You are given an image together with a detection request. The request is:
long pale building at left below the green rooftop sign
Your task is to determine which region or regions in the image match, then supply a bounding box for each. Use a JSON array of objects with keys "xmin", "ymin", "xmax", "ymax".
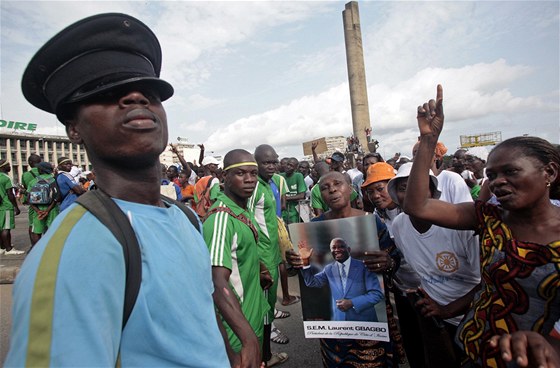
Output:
[{"xmin": 0, "ymin": 132, "xmax": 91, "ymax": 183}]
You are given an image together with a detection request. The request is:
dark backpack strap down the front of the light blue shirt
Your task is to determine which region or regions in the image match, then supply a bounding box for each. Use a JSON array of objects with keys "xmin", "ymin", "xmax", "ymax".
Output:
[{"xmin": 76, "ymin": 190, "xmax": 142, "ymax": 329}]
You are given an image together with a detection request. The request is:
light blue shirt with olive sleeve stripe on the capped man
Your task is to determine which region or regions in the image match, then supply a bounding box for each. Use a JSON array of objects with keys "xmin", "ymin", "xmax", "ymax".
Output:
[{"xmin": 4, "ymin": 200, "xmax": 229, "ymax": 367}]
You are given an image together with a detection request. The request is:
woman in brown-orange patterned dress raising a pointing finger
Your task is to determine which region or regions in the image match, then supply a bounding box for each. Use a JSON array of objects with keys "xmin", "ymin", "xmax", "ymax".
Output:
[{"xmin": 404, "ymin": 85, "xmax": 560, "ymax": 367}]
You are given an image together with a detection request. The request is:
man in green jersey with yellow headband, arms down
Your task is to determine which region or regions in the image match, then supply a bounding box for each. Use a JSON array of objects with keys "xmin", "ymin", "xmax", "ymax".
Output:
[{"xmin": 203, "ymin": 149, "xmax": 269, "ymax": 367}]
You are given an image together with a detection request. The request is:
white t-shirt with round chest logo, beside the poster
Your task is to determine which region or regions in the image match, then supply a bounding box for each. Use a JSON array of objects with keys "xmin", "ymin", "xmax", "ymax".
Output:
[{"xmin": 392, "ymin": 213, "xmax": 480, "ymax": 325}]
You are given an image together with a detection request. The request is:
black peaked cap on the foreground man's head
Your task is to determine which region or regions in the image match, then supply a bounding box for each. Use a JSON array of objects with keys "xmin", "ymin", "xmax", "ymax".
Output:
[{"xmin": 21, "ymin": 13, "xmax": 173, "ymax": 117}]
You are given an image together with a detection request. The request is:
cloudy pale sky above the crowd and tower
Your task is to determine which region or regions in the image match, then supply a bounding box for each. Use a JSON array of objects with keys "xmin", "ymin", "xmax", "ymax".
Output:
[{"xmin": 0, "ymin": 0, "xmax": 560, "ymax": 158}]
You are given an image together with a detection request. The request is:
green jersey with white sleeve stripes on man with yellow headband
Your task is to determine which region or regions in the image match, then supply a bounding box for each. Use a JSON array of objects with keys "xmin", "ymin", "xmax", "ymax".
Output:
[{"xmin": 203, "ymin": 193, "xmax": 269, "ymax": 352}]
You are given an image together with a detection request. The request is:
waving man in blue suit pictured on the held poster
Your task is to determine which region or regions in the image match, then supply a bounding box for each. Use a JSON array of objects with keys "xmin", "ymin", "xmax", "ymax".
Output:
[{"xmin": 300, "ymin": 238, "xmax": 384, "ymax": 322}]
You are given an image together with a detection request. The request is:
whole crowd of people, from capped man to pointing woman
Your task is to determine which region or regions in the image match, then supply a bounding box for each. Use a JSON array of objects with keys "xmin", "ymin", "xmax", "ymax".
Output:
[{"xmin": 4, "ymin": 13, "xmax": 560, "ymax": 368}]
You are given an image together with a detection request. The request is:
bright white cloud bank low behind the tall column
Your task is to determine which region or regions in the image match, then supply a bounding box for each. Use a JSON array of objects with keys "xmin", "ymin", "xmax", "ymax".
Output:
[{"xmin": 207, "ymin": 60, "xmax": 545, "ymax": 155}]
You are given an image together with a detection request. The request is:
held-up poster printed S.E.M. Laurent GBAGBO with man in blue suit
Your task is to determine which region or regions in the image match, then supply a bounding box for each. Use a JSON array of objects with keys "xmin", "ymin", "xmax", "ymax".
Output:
[{"xmin": 289, "ymin": 216, "xmax": 389, "ymax": 341}]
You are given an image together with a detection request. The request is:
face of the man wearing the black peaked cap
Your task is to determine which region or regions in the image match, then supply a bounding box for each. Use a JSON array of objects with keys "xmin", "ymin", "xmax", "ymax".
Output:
[{"xmin": 66, "ymin": 85, "xmax": 168, "ymax": 168}]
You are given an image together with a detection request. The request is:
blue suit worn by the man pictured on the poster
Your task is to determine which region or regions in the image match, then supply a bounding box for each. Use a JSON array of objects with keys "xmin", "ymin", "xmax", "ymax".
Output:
[{"xmin": 301, "ymin": 258, "xmax": 384, "ymax": 322}]
